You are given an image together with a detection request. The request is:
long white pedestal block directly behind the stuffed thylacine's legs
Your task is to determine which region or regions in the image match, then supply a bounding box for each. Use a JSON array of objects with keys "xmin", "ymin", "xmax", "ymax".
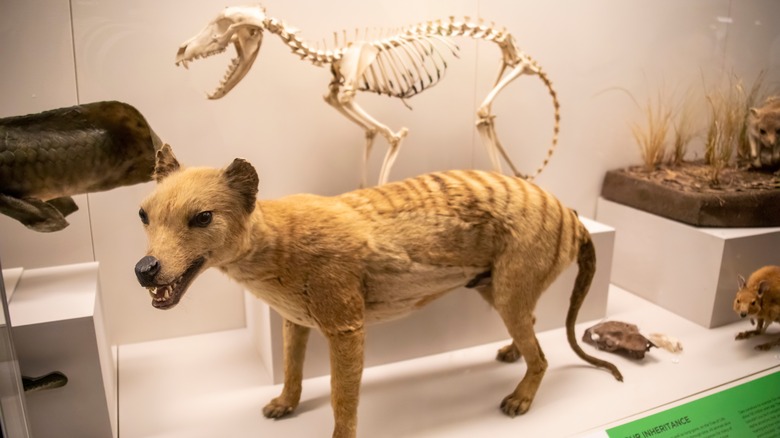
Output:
[{"xmin": 246, "ymin": 218, "xmax": 615, "ymax": 383}]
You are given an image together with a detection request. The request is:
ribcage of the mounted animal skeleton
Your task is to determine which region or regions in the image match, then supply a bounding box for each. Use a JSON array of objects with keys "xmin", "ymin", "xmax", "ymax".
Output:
[{"xmin": 359, "ymin": 34, "xmax": 458, "ymax": 99}]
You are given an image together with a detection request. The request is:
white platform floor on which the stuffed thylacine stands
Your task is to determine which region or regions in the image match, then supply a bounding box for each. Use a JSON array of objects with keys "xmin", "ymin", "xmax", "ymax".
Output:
[{"xmin": 119, "ymin": 286, "xmax": 780, "ymax": 438}]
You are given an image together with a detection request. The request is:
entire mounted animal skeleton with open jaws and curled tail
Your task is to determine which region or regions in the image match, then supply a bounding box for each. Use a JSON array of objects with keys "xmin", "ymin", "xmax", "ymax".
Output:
[{"xmin": 176, "ymin": 6, "xmax": 560, "ymax": 185}]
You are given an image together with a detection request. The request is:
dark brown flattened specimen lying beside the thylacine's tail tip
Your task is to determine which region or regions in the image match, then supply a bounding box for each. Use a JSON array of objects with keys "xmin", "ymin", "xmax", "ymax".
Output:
[{"xmin": 582, "ymin": 321, "xmax": 655, "ymax": 359}]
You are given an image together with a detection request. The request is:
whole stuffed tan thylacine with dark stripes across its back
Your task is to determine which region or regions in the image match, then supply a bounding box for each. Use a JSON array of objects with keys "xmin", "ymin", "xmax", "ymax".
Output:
[{"xmin": 137, "ymin": 149, "xmax": 621, "ymax": 436}]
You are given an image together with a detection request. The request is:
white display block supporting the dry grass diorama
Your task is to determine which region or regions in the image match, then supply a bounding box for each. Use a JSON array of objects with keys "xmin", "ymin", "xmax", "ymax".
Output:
[{"xmin": 596, "ymin": 198, "xmax": 780, "ymax": 327}]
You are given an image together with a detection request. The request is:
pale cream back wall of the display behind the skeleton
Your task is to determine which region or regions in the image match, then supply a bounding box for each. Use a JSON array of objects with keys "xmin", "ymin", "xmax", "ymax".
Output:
[{"xmin": 0, "ymin": 0, "xmax": 780, "ymax": 344}]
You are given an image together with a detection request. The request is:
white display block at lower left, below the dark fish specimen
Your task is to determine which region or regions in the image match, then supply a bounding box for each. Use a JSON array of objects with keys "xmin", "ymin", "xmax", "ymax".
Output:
[{"xmin": 8, "ymin": 263, "xmax": 118, "ymax": 438}]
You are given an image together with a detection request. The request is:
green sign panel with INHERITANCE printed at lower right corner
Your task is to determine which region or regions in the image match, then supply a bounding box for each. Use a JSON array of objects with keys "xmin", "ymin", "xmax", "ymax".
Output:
[{"xmin": 607, "ymin": 372, "xmax": 780, "ymax": 438}]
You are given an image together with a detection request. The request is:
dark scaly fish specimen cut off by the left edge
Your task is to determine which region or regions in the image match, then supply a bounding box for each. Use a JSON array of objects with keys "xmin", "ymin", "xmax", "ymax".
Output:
[{"xmin": 0, "ymin": 101, "xmax": 162, "ymax": 232}]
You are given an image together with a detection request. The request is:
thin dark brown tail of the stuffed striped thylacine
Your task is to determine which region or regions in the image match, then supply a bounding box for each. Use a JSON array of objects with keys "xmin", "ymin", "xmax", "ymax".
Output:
[{"xmin": 566, "ymin": 225, "xmax": 623, "ymax": 382}]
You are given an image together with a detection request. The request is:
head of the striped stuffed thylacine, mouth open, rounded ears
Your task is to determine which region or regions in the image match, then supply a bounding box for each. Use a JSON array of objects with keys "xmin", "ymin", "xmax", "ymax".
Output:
[{"xmin": 135, "ymin": 145, "xmax": 258, "ymax": 309}]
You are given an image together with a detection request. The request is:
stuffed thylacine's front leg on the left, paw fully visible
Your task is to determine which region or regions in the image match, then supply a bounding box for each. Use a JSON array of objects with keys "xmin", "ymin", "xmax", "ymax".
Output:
[{"xmin": 263, "ymin": 319, "xmax": 311, "ymax": 418}]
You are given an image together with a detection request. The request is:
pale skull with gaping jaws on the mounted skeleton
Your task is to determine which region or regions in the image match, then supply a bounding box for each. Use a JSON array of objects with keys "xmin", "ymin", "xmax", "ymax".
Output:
[{"xmin": 176, "ymin": 6, "xmax": 266, "ymax": 99}]
